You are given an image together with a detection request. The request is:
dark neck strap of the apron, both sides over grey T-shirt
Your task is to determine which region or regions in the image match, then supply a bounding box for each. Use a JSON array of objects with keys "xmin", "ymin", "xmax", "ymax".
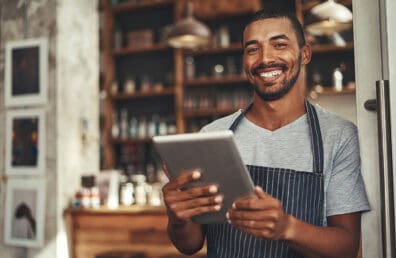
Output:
[{"xmin": 229, "ymin": 100, "xmax": 324, "ymax": 174}]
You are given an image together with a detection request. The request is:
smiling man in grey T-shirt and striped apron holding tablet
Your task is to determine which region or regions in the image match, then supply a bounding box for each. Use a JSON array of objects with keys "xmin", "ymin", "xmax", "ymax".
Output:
[{"xmin": 163, "ymin": 11, "xmax": 369, "ymax": 258}]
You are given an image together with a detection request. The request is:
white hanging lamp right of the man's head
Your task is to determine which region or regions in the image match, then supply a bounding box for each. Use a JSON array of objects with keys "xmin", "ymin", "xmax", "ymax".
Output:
[{"xmin": 306, "ymin": 0, "xmax": 352, "ymax": 36}]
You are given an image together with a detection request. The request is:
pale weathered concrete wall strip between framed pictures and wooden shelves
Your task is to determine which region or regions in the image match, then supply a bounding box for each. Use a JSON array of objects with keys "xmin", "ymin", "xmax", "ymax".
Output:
[{"xmin": 56, "ymin": 0, "xmax": 99, "ymax": 258}]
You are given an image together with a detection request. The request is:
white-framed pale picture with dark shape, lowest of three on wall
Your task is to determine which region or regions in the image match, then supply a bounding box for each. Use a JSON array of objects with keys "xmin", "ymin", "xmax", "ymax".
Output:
[{"xmin": 4, "ymin": 178, "xmax": 45, "ymax": 247}]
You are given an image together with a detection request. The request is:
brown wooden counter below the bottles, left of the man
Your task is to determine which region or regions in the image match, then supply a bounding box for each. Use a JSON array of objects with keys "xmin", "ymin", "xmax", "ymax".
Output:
[{"xmin": 65, "ymin": 206, "xmax": 206, "ymax": 258}]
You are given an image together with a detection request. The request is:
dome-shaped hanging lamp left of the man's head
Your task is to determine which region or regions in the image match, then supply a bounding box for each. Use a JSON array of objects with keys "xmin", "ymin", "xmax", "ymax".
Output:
[{"xmin": 167, "ymin": 1, "xmax": 211, "ymax": 49}]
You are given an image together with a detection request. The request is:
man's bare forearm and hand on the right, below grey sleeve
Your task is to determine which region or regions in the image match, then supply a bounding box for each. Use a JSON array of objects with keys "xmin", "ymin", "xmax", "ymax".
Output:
[{"xmin": 228, "ymin": 188, "xmax": 360, "ymax": 258}]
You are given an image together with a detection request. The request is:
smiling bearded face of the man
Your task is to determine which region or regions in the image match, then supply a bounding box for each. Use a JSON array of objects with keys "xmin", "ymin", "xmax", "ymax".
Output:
[{"xmin": 243, "ymin": 18, "xmax": 309, "ymax": 101}]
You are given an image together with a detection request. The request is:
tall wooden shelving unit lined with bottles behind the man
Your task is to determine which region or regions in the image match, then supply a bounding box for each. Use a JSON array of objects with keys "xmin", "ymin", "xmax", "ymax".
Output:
[{"xmin": 101, "ymin": 0, "xmax": 354, "ymax": 173}]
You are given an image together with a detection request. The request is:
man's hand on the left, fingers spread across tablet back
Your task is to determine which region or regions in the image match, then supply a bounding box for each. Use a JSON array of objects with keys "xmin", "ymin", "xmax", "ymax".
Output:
[{"xmin": 162, "ymin": 168, "xmax": 223, "ymax": 224}]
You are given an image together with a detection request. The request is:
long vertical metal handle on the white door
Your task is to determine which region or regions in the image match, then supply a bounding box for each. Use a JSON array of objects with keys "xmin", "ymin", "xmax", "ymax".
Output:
[{"xmin": 376, "ymin": 80, "xmax": 396, "ymax": 258}]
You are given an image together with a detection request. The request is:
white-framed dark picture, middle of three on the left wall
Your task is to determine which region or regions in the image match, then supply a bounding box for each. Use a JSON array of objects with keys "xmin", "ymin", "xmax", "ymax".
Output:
[{"xmin": 5, "ymin": 109, "xmax": 46, "ymax": 175}]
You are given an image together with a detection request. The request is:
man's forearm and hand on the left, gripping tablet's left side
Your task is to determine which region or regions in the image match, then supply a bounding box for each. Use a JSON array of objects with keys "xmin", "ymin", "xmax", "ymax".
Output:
[{"xmin": 163, "ymin": 171, "xmax": 223, "ymax": 255}]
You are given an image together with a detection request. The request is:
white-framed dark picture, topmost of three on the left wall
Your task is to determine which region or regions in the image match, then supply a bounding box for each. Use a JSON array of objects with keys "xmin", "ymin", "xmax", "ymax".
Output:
[{"xmin": 4, "ymin": 38, "xmax": 48, "ymax": 107}]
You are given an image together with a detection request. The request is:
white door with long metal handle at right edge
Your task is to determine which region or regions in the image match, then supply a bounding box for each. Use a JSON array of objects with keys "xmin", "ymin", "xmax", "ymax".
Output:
[{"xmin": 353, "ymin": 0, "xmax": 396, "ymax": 258}]
